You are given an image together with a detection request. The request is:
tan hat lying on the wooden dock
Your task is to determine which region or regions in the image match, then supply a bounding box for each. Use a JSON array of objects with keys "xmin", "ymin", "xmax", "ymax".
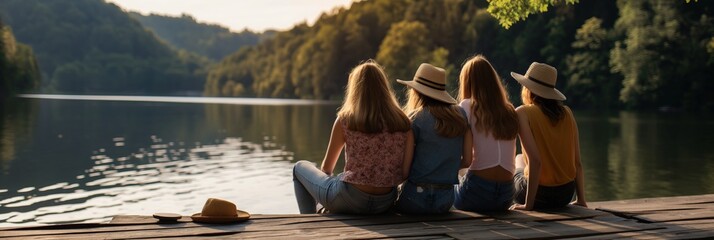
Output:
[{"xmin": 191, "ymin": 198, "xmax": 250, "ymax": 223}]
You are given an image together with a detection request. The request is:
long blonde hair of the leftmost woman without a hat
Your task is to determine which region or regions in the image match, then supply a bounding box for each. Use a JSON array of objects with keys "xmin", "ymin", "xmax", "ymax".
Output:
[{"xmin": 337, "ymin": 60, "xmax": 411, "ymax": 133}]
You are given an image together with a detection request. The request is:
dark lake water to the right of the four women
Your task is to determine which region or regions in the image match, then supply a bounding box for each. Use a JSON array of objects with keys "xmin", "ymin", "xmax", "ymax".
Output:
[{"xmin": 578, "ymin": 112, "xmax": 714, "ymax": 200}]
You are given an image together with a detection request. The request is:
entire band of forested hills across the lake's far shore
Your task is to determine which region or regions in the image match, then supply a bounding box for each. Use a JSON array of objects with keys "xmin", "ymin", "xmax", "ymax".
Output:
[{"xmin": 0, "ymin": 0, "xmax": 714, "ymax": 112}]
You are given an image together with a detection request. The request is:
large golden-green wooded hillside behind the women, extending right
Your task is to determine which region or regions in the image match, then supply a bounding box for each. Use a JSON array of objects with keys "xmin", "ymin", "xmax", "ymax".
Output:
[{"xmin": 204, "ymin": 0, "xmax": 714, "ymax": 111}]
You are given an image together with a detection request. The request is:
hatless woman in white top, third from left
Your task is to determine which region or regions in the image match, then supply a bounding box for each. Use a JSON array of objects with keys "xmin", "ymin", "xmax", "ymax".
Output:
[{"xmin": 454, "ymin": 55, "xmax": 518, "ymax": 211}]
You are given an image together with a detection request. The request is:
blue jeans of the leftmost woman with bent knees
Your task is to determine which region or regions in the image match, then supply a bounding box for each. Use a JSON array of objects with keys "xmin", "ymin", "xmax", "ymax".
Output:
[{"xmin": 293, "ymin": 160, "xmax": 397, "ymax": 214}]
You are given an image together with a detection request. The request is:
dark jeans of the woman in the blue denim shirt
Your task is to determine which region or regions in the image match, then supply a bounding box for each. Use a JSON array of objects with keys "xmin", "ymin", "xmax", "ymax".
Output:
[{"xmin": 395, "ymin": 181, "xmax": 454, "ymax": 214}]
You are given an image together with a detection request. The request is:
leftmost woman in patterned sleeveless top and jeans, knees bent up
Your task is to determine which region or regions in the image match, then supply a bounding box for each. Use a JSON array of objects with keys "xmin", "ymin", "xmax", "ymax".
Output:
[{"xmin": 293, "ymin": 60, "xmax": 414, "ymax": 214}]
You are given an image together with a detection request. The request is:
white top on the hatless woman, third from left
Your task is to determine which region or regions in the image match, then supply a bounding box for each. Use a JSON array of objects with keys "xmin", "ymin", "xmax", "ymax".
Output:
[{"xmin": 459, "ymin": 99, "xmax": 516, "ymax": 173}]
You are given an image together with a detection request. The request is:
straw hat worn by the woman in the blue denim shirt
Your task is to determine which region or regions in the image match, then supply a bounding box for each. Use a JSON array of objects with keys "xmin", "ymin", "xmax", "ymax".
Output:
[{"xmin": 397, "ymin": 63, "xmax": 456, "ymax": 104}]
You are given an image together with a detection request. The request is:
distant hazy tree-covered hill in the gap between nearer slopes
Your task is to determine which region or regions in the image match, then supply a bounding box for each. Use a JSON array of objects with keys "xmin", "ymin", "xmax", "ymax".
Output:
[{"xmin": 130, "ymin": 12, "xmax": 262, "ymax": 61}]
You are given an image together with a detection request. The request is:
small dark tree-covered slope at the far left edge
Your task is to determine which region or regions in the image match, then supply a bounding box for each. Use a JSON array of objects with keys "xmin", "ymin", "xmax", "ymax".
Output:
[{"xmin": 0, "ymin": 21, "xmax": 40, "ymax": 99}]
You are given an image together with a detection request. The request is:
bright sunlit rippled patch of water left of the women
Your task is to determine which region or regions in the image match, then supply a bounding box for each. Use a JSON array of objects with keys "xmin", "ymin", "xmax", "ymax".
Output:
[{"xmin": 0, "ymin": 136, "xmax": 297, "ymax": 226}]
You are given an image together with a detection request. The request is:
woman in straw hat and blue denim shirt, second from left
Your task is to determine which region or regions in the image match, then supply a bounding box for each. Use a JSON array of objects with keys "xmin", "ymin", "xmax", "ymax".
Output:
[{"xmin": 395, "ymin": 63, "xmax": 471, "ymax": 214}]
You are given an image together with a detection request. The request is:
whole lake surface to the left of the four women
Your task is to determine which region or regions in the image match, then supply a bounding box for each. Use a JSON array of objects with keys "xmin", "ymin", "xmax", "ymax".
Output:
[{"xmin": 0, "ymin": 96, "xmax": 337, "ymax": 226}]
